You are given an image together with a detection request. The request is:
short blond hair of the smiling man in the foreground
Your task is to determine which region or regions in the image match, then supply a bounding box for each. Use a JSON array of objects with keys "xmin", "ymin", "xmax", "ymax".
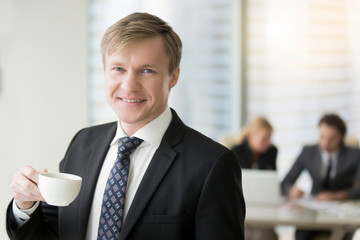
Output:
[{"xmin": 101, "ymin": 13, "xmax": 182, "ymax": 74}]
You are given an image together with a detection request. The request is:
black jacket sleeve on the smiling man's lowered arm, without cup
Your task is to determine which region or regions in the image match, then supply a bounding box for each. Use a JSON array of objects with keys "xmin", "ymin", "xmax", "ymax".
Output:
[{"xmin": 195, "ymin": 151, "xmax": 245, "ymax": 240}]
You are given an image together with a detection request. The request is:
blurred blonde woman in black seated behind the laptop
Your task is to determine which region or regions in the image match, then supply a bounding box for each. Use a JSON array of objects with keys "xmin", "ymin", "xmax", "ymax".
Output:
[{"xmin": 232, "ymin": 117, "xmax": 278, "ymax": 240}]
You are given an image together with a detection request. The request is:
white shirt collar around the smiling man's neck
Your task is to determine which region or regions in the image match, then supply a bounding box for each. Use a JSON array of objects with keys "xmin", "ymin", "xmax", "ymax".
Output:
[{"xmin": 110, "ymin": 107, "xmax": 172, "ymax": 148}]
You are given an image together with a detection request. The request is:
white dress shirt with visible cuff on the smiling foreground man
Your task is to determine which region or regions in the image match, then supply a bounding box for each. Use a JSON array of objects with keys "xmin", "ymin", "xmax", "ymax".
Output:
[{"xmin": 13, "ymin": 107, "xmax": 172, "ymax": 240}]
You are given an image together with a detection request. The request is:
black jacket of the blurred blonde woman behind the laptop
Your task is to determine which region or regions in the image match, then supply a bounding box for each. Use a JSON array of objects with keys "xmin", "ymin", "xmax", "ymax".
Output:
[{"xmin": 232, "ymin": 140, "xmax": 277, "ymax": 170}]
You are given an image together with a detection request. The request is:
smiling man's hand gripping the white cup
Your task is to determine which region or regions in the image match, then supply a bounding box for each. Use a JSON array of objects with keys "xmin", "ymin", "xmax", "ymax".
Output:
[{"xmin": 10, "ymin": 167, "xmax": 47, "ymax": 209}]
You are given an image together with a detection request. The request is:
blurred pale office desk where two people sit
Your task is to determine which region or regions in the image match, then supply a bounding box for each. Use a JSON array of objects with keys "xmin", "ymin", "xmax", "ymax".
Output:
[{"xmin": 245, "ymin": 202, "xmax": 360, "ymax": 240}]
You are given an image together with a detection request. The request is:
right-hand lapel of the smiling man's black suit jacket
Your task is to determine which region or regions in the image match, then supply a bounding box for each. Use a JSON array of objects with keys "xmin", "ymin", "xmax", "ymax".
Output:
[{"xmin": 120, "ymin": 110, "xmax": 185, "ymax": 240}]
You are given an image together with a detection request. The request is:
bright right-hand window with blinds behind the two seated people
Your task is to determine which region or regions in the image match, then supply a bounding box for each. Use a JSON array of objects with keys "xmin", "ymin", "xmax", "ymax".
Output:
[{"xmin": 246, "ymin": 0, "xmax": 360, "ymax": 181}]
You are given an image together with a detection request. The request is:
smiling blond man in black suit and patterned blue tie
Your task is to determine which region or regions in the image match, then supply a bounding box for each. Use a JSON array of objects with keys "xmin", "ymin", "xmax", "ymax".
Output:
[{"xmin": 7, "ymin": 13, "xmax": 245, "ymax": 240}]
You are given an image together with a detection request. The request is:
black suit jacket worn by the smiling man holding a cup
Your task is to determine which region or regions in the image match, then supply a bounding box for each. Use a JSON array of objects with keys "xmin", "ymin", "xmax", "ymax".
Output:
[{"xmin": 7, "ymin": 111, "xmax": 245, "ymax": 240}]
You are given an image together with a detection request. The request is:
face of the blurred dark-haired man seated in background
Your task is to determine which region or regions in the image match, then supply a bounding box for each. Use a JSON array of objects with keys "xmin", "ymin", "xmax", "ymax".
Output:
[{"xmin": 319, "ymin": 123, "xmax": 343, "ymax": 153}]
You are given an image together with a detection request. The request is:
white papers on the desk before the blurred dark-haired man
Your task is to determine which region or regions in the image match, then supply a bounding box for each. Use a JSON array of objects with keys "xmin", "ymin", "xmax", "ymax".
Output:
[{"xmin": 293, "ymin": 198, "xmax": 360, "ymax": 218}]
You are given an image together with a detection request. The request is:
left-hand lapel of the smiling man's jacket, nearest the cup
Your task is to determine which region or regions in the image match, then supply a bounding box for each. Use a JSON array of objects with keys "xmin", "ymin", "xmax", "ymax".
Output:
[{"xmin": 79, "ymin": 123, "xmax": 117, "ymax": 239}]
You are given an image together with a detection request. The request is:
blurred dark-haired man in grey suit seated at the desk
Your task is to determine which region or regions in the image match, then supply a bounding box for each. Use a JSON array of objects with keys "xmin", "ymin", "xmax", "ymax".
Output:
[{"xmin": 281, "ymin": 114, "xmax": 360, "ymax": 240}]
